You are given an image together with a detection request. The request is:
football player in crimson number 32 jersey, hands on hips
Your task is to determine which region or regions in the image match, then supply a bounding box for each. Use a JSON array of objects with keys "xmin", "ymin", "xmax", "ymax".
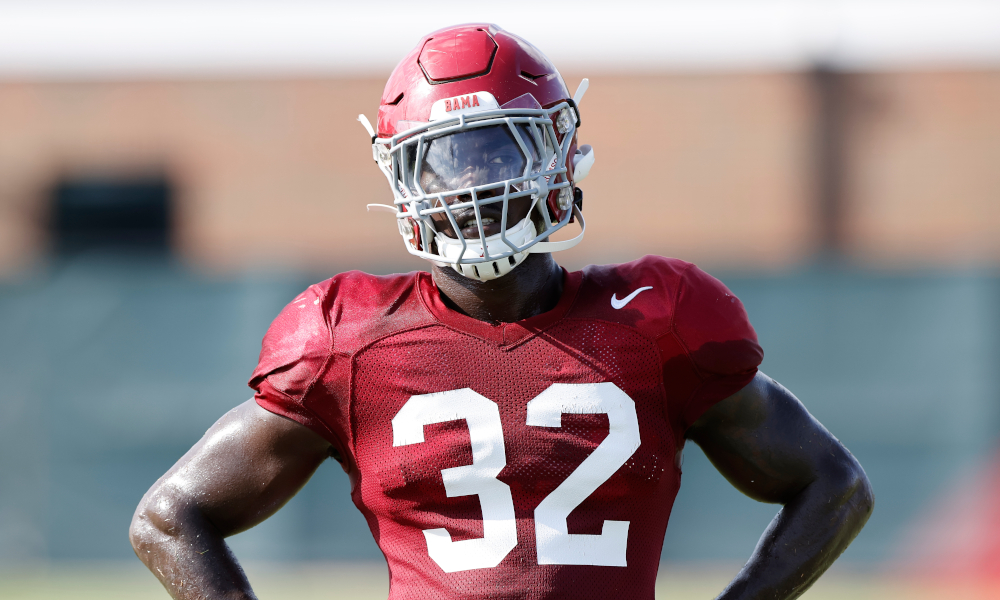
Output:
[{"xmin": 131, "ymin": 24, "xmax": 873, "ymax": 600}]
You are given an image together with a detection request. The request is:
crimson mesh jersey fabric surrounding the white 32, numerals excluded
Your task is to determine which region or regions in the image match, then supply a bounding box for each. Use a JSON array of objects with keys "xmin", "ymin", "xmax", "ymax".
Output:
[{"xmin": 251, "ymin": 257, "xmax": 761, "ymax": 600}]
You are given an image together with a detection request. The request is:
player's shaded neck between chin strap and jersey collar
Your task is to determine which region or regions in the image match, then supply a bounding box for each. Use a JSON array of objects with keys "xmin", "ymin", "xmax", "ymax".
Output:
[{"xmin": 431, "ymin": 254, "xmax": 563, "ymax": 323}]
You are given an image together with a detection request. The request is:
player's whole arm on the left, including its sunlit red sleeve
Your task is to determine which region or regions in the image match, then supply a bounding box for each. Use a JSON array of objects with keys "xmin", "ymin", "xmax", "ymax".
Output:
[{"xmin": 129, "ymin": 284, "xmax": 346, "ymax": 600}]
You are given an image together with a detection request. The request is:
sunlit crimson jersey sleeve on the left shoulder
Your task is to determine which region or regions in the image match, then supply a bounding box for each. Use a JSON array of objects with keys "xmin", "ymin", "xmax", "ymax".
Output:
[{"xmin": 249, "ymin": 285, "xmax": 343, "ymax": 448}]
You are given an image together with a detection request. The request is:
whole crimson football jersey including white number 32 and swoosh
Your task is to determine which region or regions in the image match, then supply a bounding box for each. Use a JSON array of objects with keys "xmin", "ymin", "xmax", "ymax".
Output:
[{"xmin": 250, "ymin": 256, "xmax": 763, "ymax": 600}]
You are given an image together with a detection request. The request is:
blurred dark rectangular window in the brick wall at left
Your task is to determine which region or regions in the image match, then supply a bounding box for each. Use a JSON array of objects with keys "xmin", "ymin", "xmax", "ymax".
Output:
[{"xmin": 51, "ymin": 177, "xmax": 173, "ymax": 254}]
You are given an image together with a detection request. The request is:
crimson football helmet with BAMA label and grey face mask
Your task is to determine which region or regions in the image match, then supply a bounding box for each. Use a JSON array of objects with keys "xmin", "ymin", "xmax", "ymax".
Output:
[{"xmin": 358, "ymin": 24, "xmax": 594, "ymax": 281}]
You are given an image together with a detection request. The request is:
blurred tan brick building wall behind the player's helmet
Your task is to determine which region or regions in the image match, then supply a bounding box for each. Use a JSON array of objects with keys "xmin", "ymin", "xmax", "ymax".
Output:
[{"xmin": 0, "ymin": 71, "xmax": 1000, "ymax": 276}]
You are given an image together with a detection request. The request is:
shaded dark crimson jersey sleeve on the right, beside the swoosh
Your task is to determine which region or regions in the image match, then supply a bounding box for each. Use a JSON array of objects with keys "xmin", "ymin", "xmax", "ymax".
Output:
[{"xmin": 673, "ymin": 265, "xmax": 764, "ymax": 431}]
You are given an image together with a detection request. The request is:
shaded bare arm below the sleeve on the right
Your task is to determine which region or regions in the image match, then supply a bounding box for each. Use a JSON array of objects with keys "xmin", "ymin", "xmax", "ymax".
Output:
[{"xmin": 687, "ymin": 373, "xmax": 875, "ymax": 600}]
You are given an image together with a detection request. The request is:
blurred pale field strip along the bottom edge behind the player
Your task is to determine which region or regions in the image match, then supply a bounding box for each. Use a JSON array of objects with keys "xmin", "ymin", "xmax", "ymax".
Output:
[{"xmin": 0, "ymin": 562, "xmax": 1000, "ymax": 600}]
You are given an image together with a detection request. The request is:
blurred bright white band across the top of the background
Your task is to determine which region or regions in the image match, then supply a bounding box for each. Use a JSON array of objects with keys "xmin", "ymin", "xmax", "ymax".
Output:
[{"xmin": 0, "ymin": 0, "xmax": 1000, "ymax": 78}]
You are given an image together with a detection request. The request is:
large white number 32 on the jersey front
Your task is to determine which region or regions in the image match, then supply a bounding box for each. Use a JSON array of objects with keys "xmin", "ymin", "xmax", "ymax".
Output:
[{"xmin": 392, "ymin": 382, "xmax": 640, "ymax": 573}]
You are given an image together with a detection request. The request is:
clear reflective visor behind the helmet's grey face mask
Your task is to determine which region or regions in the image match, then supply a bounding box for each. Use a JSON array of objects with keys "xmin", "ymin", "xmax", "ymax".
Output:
[{"xmin": 410, "ymin": 124, "xmax": 542, "ymax": 203}]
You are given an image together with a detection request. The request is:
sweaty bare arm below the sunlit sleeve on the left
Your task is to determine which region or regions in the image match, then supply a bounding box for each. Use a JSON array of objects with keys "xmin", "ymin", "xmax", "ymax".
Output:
[{"xmin": 129, "ymin": 400, "xmax": 331, "ymax": 600}]
